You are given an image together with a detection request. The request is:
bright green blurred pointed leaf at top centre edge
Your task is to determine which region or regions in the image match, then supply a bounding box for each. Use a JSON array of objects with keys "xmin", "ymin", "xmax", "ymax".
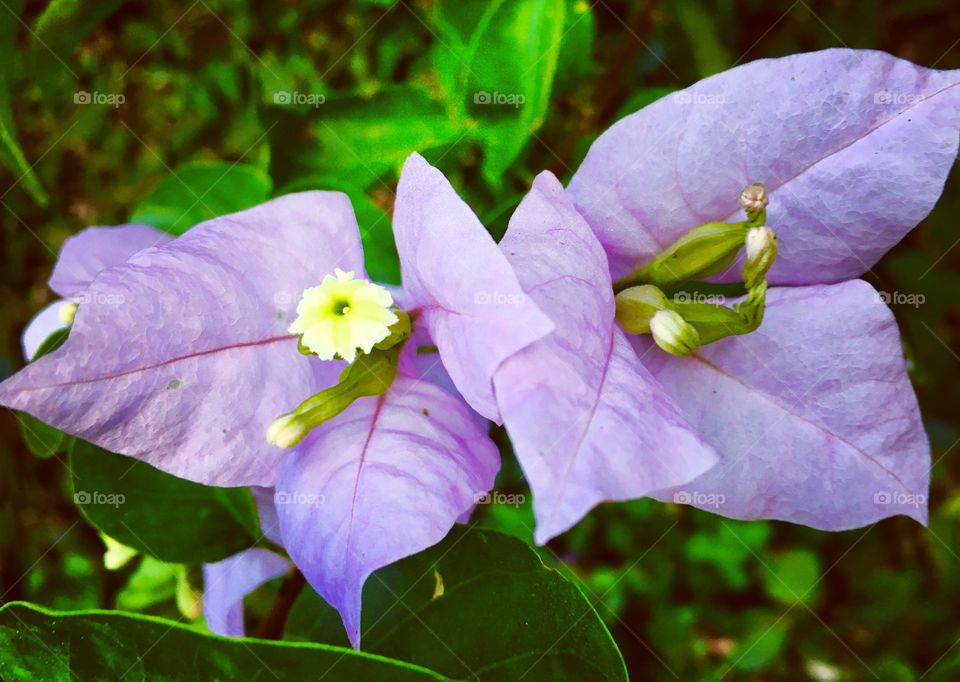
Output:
[{"xmin": 445, "ymin": 0, "xmax": 567, "ymax": 187}]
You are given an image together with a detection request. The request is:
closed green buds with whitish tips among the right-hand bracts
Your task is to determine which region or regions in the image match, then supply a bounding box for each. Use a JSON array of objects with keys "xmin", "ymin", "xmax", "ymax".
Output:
[{"xmin": 615, "ymin": 183, "xmax": 777, "ymax": 356}]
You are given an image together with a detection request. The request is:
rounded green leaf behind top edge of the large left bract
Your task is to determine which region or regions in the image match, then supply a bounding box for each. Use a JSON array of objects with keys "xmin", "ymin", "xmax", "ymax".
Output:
[{"xmin": 130, "ymin": 161, "xmax": 273, "ymax": 235}]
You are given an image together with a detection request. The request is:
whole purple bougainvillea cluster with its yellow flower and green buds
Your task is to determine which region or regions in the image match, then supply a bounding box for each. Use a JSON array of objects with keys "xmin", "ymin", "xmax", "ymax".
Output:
[{"xmin": 0, "ymin": 50, "xmax": 960, "ymax": 646}]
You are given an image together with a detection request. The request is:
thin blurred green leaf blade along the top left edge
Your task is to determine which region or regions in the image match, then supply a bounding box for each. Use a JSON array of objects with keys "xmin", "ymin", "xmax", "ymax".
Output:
[{"xmin": 0, "ymin": 0, "xmax": 48, "ymax": 206}]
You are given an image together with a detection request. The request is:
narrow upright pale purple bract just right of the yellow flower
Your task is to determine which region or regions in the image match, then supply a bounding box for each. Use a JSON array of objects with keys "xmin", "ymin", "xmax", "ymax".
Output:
[{"xmin": 393, "ymin": 154, "xmax": 552, "ymax": 422}]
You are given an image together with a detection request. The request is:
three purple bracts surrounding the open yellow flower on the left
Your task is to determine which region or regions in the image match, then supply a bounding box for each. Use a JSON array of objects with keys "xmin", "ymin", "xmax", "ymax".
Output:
[{"xmin": 0, "ymin": 155, "xmax": 552, "ymax": 645}]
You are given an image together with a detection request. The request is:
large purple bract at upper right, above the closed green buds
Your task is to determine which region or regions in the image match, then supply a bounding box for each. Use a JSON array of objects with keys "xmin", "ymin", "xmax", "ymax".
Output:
[{"xmin": 569, "ymin": 49, "xmax": 960, "ymax": 284}]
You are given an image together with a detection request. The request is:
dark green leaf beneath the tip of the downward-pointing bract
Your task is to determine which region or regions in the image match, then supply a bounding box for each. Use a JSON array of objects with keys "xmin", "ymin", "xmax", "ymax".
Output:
[{"xmin": 286, "ymin": 526, "xmax": 626, "ymax": 682}]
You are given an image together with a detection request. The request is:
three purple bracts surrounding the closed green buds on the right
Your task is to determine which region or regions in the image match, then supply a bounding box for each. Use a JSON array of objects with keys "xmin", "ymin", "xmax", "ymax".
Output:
[{"xmin": 495, "ymin": 50, "xmax": 960, "ymax": 542}]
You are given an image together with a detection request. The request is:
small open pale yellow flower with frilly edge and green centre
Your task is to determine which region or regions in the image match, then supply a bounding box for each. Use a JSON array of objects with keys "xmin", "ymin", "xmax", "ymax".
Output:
[{"xmin": 290, "ymin": 269, "xmax": 398, "ymax": 362}]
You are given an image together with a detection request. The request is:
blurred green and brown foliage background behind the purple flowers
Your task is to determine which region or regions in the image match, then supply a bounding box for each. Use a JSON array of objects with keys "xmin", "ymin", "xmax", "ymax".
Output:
[{"xmin": 0, "ymin": 0, "xmax": 960, "ymax": 681}]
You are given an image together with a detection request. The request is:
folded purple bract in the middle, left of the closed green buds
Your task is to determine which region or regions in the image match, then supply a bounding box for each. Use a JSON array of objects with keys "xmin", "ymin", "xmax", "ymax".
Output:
[{"xmin": 494, "ymin": 172, "xmax": 716, "ymax": 543}]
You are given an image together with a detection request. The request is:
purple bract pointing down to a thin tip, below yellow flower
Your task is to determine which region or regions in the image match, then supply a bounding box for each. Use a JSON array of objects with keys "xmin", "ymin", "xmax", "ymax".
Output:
[{"xmin": 276, "ymin": 376, "xmax": 500, "ymax": 647}]
